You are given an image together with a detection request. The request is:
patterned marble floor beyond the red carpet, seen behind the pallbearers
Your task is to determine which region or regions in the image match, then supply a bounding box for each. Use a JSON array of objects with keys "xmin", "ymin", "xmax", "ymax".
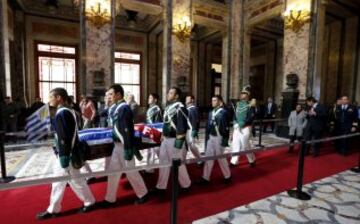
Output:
[{"xmin": 2, "ymin": 130, "xmax": 287, "ymax": 181}]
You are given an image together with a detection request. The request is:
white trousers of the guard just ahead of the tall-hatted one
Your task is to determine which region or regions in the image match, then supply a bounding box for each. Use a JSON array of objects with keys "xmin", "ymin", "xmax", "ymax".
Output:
[{"xmin": 203, "ymin": 135, "xmax": 231, "ymax": 180}]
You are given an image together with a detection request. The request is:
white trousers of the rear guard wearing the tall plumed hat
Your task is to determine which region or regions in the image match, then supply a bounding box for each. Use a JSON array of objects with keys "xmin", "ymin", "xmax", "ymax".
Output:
[{"xmin": 231, "ymin": 126, "xmax": 255, "ymax": 165}]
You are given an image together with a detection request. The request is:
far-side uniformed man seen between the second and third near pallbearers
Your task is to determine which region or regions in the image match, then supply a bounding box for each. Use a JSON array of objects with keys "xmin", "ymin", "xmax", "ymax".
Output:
[{"xmin": 146, "ymin": 93, "xmax": 162, "ymax": 173}]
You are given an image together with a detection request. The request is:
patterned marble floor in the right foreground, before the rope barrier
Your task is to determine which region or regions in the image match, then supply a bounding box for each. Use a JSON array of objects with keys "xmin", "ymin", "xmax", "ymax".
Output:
[{"xmin": 193, "ymin": 171, "xmax": 360, "ymax": 224}]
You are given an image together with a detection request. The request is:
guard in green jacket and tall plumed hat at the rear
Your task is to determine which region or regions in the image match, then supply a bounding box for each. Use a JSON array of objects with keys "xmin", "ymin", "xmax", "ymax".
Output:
[{"xmin": 231, "ymin": 90, "xmax": 255, "ymax": 167}]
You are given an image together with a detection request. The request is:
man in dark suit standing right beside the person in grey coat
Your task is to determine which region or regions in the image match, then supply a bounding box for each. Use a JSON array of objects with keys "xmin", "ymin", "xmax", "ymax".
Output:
[{"xmin": 304, "ymin": 97, "xmax": 327, "ymax": 157}]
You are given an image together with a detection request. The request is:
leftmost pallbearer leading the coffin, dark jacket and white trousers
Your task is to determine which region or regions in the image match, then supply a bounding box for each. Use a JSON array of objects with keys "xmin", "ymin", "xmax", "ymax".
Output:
[{"xmin": 37, "ymin": 88, "xmax": 95, "ymax": 220}]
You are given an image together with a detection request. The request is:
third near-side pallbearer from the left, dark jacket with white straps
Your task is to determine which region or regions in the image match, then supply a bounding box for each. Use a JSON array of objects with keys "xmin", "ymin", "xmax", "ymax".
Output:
[{"xmin": 155, "ymin": 87, "xmax": 191, "ymax": 192}]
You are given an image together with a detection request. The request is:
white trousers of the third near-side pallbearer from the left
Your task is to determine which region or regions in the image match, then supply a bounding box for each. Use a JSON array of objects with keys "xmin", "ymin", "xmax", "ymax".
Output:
[{"xmin": 156, "ymin": 137, "xmax": 191, "ymax": 189}]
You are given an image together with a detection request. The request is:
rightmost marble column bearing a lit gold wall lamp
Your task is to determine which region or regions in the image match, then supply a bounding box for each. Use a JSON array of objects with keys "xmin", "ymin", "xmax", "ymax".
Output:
[{"xmin": 283, "ymin": 0, "xmax": 325, "ymax": 100}]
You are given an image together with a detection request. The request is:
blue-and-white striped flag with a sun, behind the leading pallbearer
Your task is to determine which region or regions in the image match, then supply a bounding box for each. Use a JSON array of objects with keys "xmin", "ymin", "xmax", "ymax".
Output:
[{"xmin": 25, "ymin": 104, "xmax": 51, "ymax": 142}]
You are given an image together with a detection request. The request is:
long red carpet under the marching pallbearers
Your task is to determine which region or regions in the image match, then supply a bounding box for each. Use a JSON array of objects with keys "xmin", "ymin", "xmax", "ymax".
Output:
[{"xmin": 0, "ymin": 144, "xmax": 358, "ymax": 224}]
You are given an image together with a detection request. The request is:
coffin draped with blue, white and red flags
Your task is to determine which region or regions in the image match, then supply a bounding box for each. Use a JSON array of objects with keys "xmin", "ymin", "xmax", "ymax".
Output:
[{"xmin": 79, "ymin": 123, "xmax": 163, "ymax": 160}]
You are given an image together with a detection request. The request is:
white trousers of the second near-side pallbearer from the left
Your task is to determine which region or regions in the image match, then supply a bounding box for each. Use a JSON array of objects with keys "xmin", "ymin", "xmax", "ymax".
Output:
[{"xmin": 105, "ymin": 142, "xmax": 148, "ymax": 202}]
